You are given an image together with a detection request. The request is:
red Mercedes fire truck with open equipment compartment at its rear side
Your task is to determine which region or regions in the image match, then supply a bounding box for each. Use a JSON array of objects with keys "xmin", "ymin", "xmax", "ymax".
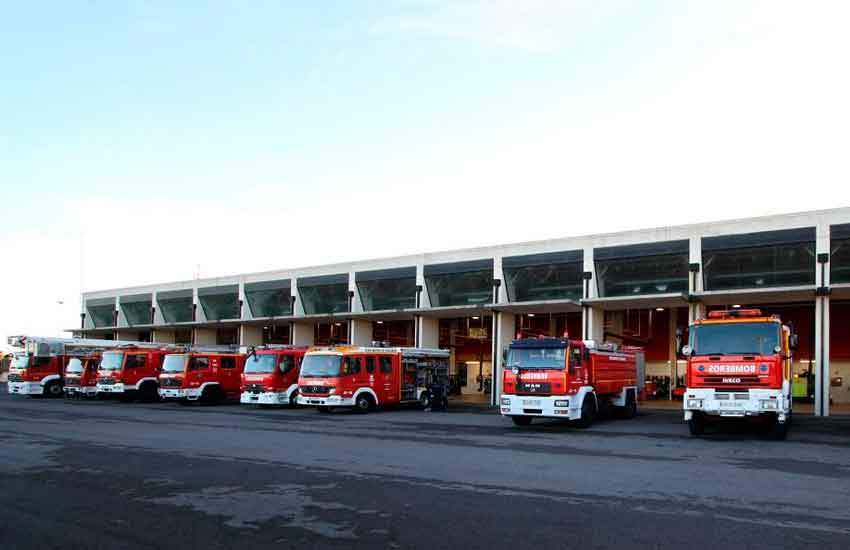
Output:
[{"xmin": 298, "ymin": 346, "xmax": 449, "ymax": 412}]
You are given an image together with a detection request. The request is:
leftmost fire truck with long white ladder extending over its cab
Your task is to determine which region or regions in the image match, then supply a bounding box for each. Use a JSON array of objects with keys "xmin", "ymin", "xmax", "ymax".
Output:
[{"xmin": 8, "ymin": 336, "xmax": 143, "ymax": 397}]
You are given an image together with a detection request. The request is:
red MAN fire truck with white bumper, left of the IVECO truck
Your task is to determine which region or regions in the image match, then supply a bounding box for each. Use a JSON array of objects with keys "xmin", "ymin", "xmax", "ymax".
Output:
[{"xmin": 500, "ymin": 336, "xmax": 646, "ymax": 428}]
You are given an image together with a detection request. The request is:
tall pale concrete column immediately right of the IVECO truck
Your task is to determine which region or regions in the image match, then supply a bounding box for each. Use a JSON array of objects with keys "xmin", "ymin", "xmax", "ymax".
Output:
[{"xmin": 815, "ymin": 223, "xmax": 830, "ymax": 416}]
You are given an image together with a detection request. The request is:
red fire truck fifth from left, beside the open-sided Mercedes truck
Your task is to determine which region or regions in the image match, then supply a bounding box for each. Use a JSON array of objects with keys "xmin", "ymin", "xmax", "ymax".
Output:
[{"xmin": 239, "ymin": 344, "xmax": 309, "ymax": 406}]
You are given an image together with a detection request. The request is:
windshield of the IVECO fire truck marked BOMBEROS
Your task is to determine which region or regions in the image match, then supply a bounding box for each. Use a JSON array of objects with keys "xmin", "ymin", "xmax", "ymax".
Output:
[{"xmin": 691, "ymin": 323, "xmax": 780, "ymax": 355}]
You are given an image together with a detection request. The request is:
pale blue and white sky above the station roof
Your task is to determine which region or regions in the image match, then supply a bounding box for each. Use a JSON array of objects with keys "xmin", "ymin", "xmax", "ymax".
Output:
[{"xmin": 0, "ymin": 0, "xmax": 850, "ymax": 335}]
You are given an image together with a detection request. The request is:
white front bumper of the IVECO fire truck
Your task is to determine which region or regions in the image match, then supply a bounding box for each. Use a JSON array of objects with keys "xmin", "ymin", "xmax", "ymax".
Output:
[{"xmin": 683, "ymin": 388, "xmax": 791, "ymax": 422}]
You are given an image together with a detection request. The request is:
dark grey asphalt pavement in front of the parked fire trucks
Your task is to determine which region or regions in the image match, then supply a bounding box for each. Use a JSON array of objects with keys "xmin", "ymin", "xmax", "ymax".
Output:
[{"xmin": 0, "ymin": 385, "xmax": 850, "ymax": 550}]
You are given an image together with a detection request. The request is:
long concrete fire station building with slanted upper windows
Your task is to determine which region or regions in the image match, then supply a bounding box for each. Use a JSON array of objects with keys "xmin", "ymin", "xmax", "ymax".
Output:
[{"xmin": 74, "ymin": 208, "xmax": 850, "ymax": 415}]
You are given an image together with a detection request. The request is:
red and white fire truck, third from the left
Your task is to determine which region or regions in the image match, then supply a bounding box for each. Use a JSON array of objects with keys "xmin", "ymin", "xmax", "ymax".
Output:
[{"xmin": 97, "ymin": 343, "xmax": 176, "ymax": 402}]
